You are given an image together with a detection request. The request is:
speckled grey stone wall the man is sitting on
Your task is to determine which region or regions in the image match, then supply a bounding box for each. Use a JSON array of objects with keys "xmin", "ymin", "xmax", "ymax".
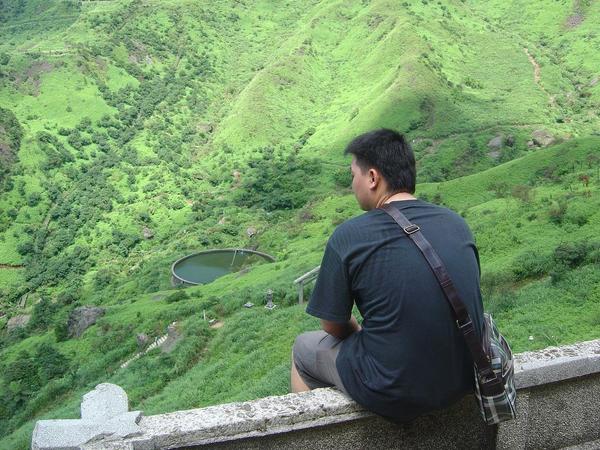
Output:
[{"xmin": 32, "ymin": 340, "xmax": 600, "ymax": 450}]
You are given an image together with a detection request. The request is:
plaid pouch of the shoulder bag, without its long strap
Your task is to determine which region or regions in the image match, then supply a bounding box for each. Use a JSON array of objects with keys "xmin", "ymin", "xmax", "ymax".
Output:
[{"xmin": 474, "ymin": 313, "xmax": 517, "ymax": 425}]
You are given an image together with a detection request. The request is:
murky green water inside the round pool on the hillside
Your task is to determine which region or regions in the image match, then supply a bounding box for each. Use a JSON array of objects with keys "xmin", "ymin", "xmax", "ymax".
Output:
[{"xmin": 173, "ymin": 250, "xmax": 267, "ymax": 284}]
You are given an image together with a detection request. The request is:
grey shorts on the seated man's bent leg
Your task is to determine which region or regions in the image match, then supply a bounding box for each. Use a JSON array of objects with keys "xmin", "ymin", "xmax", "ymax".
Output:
[{"xmin": 292, "ymin": 331, "xmax": 347, "ymax": 394}]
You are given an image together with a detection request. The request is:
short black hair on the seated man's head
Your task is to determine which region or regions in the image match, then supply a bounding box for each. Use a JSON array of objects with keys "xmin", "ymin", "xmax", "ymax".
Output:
[{"xmin": 344, "ymin": 128, "xmax": 417, "ymax": 194}]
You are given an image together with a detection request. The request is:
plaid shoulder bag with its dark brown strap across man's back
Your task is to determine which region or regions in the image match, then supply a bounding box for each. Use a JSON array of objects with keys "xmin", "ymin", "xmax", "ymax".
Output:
[{"xmin": 381, "ymin": 204, "xmax": 517, "ymax": 425}]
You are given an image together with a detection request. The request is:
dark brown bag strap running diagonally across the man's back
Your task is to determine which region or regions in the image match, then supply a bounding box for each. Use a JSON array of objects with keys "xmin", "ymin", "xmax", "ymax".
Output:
[{"xmin": 380, "ymin": 203, "xmax": 502, "ymax": 387}]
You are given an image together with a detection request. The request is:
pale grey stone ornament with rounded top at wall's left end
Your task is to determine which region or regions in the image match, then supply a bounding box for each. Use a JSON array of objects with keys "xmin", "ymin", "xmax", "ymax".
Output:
[{"xmin": 31, "ymin": 383, "xmax": 142, "ymax": 450}]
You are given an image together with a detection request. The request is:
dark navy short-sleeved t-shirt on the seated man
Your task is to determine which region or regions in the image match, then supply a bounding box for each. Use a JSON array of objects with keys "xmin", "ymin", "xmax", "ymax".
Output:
[{"xmin": 306, "ymin": 200, "xmax": 483, "ymax": 421}]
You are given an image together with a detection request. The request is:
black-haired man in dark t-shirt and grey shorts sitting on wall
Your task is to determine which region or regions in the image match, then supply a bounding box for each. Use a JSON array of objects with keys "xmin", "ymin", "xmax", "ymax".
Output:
[{"xmin": 291, "ymin": 129, "xmax": 483, "ymax": 421}]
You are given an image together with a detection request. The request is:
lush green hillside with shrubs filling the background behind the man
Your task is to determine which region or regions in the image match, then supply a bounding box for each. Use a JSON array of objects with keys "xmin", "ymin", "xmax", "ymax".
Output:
[{"xmin": 0, "ymin": 0, "xmax": 600, "ymax": 448}]
